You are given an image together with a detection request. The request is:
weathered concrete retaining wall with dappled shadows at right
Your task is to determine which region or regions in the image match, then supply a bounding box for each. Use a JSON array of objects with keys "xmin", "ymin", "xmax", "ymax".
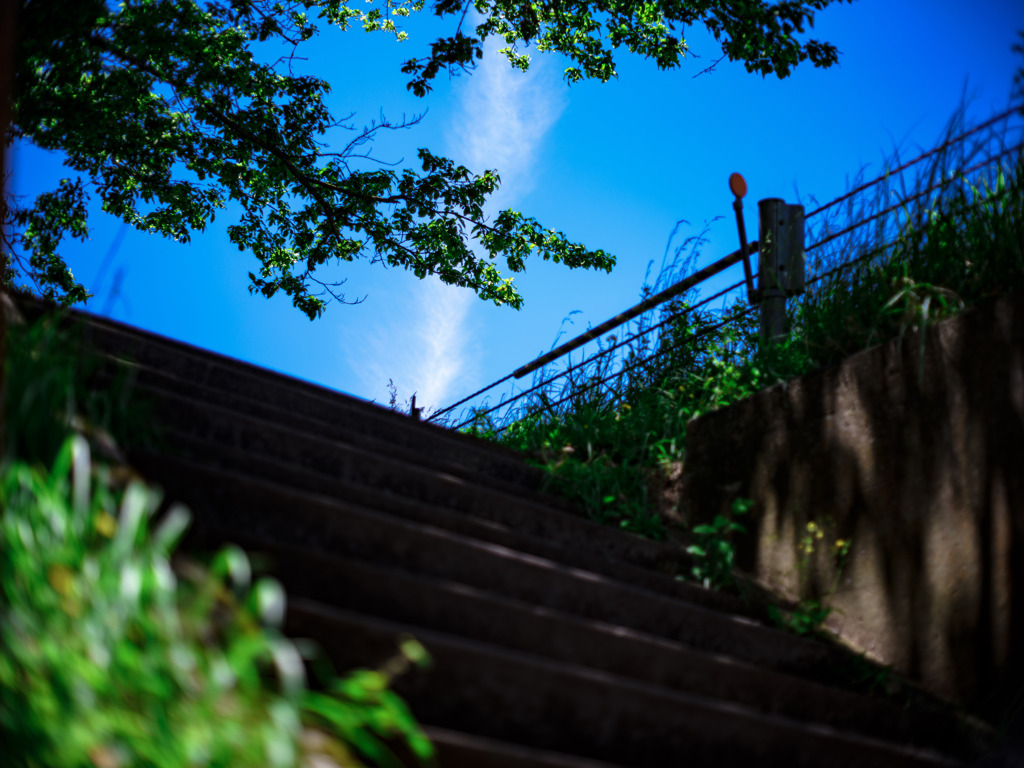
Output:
[{"xmin": 681, "ymin": 295, "xmax": 1024, "ymax": 711}]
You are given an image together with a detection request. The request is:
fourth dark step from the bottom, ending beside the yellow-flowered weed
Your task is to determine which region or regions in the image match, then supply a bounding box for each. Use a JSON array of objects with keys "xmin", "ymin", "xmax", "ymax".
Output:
[{"xmin": 161, "ymin": 462, "xmax": 837, "ymax": 678}]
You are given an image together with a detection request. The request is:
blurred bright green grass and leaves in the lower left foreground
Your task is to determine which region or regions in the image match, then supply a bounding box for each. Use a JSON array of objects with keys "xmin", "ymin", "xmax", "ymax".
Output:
[{"xmin": 0, "ymin": 318, "xmax": 433, "ymax": 768}]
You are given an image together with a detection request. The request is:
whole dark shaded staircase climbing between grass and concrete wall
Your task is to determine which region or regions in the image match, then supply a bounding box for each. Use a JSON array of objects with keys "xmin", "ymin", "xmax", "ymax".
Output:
[{"xmin": 41, "ymin": 303, "xmax": 999, "ymax": 768}]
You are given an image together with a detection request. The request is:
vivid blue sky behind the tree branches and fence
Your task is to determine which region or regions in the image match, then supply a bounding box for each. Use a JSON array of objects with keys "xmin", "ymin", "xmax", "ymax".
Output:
[{"xmin": 13, "ymin": 0, "xmax": 1024, "ymax": 417}]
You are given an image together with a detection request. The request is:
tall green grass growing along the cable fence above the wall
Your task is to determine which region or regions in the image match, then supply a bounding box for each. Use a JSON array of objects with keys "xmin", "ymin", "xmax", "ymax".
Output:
[{"xmin": 467, "ymin": 96, "xmax": 1024, "ymax": 539}]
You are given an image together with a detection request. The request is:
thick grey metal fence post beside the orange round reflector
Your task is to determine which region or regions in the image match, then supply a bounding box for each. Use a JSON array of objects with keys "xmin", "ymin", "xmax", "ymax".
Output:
[{"xmin": 758, "ymin": 198, "xmax": 804, "ymax": 343}]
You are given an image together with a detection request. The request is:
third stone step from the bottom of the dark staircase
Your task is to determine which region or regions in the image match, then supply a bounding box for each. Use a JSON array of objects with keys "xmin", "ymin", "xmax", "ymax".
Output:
[{"xmin": 201, "ymin": 531, "xmax": 970, "ymax": 756}]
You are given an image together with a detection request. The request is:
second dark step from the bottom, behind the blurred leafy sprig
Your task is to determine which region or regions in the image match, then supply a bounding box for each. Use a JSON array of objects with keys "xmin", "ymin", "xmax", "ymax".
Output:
[{"xmin": 286, "ymin": 598, "xmax": 962, "ymax": 768}]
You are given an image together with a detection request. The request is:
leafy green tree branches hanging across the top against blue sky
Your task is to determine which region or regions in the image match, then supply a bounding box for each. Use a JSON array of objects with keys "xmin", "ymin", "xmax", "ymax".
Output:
[{"xmin": 3, "ymin": 0, "xmax": 843, "ymax": 318}]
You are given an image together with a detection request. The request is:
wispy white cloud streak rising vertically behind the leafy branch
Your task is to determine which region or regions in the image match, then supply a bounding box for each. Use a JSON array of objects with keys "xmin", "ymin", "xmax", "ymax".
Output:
[{"xmin": 348, "ymin": 37, "xmax": 564, "ymax": 408}]
